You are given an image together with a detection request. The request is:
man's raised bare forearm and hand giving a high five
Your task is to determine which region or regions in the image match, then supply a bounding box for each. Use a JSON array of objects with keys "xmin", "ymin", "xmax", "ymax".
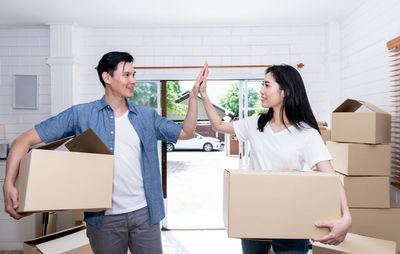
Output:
[{"xmin": 178, "ymin": 62, "xmax": 208, "ymax": 139}]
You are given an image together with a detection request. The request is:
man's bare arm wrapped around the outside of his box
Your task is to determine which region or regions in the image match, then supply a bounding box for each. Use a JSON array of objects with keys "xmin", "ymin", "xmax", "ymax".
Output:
[{"xmin": 3, "ymin": 128, "xmax": 42, "ymax": 219}]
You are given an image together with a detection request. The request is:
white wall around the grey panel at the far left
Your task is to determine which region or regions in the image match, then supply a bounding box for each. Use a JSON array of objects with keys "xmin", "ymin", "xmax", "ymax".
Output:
[{"xmin": 0, "ymin": 27, "xmax": 50, "ymax": 250}]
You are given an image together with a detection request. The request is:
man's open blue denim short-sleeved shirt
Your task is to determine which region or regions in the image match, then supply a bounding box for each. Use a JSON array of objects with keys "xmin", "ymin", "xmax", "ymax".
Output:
[{"xmin": 35, "ymin": 97, "xmax": 182, "ymax": 228}]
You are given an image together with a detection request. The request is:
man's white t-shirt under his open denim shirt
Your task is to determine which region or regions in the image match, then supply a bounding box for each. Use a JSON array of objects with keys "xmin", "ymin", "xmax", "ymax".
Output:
[{"xmin": 106, "ymin": 111, "xmax": 147, "ymax": 215}]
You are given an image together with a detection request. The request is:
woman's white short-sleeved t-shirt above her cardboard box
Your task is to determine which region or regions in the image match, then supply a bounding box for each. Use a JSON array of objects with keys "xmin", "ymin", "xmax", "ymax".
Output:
[{"xmin": 233, "ymin": 115, "xmax": 332, "ymax": 171}]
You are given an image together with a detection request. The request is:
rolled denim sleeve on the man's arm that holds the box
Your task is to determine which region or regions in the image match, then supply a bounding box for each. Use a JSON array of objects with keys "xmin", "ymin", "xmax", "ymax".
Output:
[{"xmin": 35, "ymin": 107, "xmax": 75, "ymax": 143}]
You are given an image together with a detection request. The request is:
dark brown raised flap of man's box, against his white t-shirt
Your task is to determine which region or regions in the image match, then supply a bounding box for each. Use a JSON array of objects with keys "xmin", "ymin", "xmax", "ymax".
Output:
[{"xmin": 65, "ymin": 128, "xmax": 112, "ymax": 154}]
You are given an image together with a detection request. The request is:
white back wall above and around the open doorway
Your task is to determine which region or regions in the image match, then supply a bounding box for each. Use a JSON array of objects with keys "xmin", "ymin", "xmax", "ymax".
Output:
[{"xmin": 77, "ymin": 25, "xmax": 329, "ymax": 121}]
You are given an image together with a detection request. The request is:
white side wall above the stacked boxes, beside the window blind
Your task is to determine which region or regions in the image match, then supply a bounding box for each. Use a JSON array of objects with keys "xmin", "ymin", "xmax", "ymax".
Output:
[{"xmin": 340, "ymin": 0, "xmax": 400, "ymax": 203}]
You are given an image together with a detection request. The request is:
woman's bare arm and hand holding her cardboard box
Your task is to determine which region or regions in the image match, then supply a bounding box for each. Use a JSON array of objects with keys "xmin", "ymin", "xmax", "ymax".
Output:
[{"xmin": 314, "ymin": 161, "xmax": 351, "ymax": 245}]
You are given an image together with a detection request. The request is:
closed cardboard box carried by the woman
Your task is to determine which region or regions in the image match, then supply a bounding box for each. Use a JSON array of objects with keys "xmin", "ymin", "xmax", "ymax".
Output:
[{"xmin": 223, "ymin": 170, "xmax": 341, "ymax": 239}]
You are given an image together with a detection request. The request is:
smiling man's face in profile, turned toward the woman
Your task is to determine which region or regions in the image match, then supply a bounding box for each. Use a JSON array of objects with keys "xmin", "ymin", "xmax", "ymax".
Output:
[{"xmin": 104, "ymin": 62, "xmax": 136, "ymax": 99}]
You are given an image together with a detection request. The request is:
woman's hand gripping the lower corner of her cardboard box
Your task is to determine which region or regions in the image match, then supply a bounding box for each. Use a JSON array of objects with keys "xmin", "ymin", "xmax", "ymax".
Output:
[{"xmin": 313, "ymin": 217, "xmax": 351, "ymax": 245}]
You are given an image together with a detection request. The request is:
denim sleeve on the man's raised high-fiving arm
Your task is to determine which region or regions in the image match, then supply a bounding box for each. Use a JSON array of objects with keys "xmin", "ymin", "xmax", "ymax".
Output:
[{"xmin": 153, "ymin": 110, "xmax": 182, "ymax": 143}]
